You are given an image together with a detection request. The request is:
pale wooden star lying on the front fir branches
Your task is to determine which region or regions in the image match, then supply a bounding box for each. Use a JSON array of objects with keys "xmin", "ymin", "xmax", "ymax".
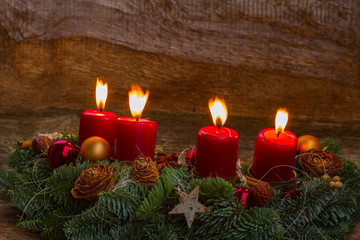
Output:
[{"xmin": 169, "ymin": 185, "xmax": 210, "ymax": 228}]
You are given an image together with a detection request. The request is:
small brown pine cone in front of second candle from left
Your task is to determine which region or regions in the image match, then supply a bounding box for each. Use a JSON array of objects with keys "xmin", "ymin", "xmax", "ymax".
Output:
[{"xmin": 131, "ymin": 156, "xmax": 159, "ymax": 185}]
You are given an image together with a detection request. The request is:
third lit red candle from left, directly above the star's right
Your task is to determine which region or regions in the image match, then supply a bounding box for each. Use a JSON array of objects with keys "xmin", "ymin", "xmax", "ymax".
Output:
[{"xmin": 194, "ymin": 97, "xmax": 239, "ymax": 178}]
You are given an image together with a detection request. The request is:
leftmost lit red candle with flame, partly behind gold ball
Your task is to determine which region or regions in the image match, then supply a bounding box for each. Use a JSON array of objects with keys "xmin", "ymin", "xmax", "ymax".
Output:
[{"xmin": 78, "ymin": 79, "xmax": 119, "ymax": 152}]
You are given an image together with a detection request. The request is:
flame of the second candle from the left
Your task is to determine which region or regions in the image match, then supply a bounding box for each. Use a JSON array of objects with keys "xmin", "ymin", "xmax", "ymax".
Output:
[{"xmin": 129, "ymin": 84, "xmax": 149, "ymax": 119}]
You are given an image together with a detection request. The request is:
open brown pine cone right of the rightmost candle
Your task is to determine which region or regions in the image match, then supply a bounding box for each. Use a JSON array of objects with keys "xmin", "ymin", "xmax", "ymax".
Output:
[{"xmin": 299, "ymin": 149, "xmax": 343, "ymax": 177}]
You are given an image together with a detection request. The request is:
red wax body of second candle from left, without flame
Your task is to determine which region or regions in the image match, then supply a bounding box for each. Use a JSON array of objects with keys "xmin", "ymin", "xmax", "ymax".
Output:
[{"xmin": 114, "ymin": 117, "xmax": 157, "ymax": 162}]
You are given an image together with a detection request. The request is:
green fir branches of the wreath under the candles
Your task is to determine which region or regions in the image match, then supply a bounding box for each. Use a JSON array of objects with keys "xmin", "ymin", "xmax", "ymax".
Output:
[{"xmin": 0, "ymin": 136, "xmax": 360, "ymax": 240}]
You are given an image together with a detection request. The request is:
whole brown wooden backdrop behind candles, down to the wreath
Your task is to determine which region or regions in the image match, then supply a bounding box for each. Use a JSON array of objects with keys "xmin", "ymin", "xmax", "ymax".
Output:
[{"xmin": 0, "ymin": 0, "xmax": 360, "ymax": 239}]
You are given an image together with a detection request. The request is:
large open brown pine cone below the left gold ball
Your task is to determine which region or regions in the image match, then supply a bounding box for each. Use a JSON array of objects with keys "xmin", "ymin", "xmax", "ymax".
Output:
[{"xmin": 71, "ymin": 164, "xmax": 117, "ymax": 201}]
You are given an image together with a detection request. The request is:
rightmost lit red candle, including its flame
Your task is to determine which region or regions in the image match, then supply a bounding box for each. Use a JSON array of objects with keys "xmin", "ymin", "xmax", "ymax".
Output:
[{"xmin": 251, "ymin": 110, "xmax": 297, "ymax": 182}]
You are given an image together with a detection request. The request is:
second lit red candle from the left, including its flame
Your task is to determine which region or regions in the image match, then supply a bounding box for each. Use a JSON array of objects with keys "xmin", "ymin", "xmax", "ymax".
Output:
[{"xmin": 114, "ymin": 85, "xmax": 157, "ymax": 162}]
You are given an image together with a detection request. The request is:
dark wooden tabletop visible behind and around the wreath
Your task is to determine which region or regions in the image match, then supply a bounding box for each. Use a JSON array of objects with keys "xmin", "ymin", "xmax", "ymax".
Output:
[{"xmin": 0, "ymin": 109, "xmax": 360, "ymax": 240}]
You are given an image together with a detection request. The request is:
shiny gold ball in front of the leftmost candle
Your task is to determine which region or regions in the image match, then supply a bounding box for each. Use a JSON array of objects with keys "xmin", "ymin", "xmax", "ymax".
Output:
[{"xmin": 80, "ymin": 137, "xmax": 110, "ymax": 163}]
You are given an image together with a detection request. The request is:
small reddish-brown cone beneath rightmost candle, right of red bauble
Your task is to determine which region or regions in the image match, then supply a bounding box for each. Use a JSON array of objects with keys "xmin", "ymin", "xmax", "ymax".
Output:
[{"xmin": 249, "ymin": 182, "xmax": 274, "ymax": 207}]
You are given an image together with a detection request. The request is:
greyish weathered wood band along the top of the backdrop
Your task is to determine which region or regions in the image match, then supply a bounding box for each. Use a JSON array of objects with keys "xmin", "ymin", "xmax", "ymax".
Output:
[{"xmin": 0, "ymin": 0, "xmax": 359, "ymax": 80}]
